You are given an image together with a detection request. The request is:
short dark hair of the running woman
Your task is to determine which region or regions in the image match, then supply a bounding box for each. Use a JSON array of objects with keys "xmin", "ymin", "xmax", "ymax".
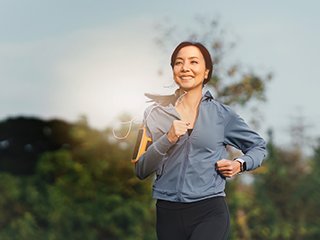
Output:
[{"xmin": 170, "ymin": 41, "xmax": 213, "ymax": 84}]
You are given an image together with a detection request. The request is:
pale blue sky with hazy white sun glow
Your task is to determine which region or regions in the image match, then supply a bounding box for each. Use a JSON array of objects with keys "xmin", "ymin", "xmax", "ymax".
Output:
[{"xmin": 0, "ymin": 0, "xmax": 320, "ymax": 149}]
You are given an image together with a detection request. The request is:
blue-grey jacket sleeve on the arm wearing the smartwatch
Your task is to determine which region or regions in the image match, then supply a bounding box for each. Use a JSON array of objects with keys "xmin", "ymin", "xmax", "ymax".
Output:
[{"xmin": 225, "ymin": 107, "xmax": 267, "ymax": 170}]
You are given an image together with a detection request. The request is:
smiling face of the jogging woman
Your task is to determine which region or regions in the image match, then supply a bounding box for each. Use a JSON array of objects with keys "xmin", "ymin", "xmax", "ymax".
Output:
[{"xmin": 173, "ymin": 46, "xmax": 209, "ymax": 91}]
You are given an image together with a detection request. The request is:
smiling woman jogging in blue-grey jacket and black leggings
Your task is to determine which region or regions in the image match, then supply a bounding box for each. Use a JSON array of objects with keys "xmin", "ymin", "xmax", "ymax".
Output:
[{"xmin": 135, "ymin": 42, "xmax": 266, "ymax": 240}]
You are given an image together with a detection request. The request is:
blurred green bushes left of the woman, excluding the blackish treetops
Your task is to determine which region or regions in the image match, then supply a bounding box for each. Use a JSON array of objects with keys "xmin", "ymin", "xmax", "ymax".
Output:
[{"xmin": 0, "ymin": 121, "xmax": 155, "ymax": 240}]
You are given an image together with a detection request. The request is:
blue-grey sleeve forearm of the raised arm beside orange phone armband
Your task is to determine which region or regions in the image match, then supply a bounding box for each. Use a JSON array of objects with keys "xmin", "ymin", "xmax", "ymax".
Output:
[{"xmin": 135, "ymin": 108, "xmax": 174, "ymax": 179}]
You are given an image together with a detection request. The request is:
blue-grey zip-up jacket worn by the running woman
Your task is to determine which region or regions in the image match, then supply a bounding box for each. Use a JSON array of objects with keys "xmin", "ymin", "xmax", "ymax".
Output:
[{"xmin": 135, "ymin": 91, "xmax": 266, "ymax": 202}]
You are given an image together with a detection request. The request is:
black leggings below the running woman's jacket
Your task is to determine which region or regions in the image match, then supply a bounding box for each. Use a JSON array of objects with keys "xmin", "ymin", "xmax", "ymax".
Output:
[{"xmin": 157, "ymin": 197, "xmax": 230, "ymax": 240}]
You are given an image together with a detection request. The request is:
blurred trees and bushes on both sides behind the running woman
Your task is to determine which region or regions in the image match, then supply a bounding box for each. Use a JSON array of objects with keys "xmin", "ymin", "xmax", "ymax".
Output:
[{"xmin": 0, "ymin": 113, "xmax": 320, "ymax": 240}]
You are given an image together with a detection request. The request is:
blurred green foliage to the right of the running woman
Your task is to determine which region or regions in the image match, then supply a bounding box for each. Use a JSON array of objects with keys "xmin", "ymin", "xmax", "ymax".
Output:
[{"xmin": 227, "ymin": 131, "xmax": 320, "ymax": 240}]
